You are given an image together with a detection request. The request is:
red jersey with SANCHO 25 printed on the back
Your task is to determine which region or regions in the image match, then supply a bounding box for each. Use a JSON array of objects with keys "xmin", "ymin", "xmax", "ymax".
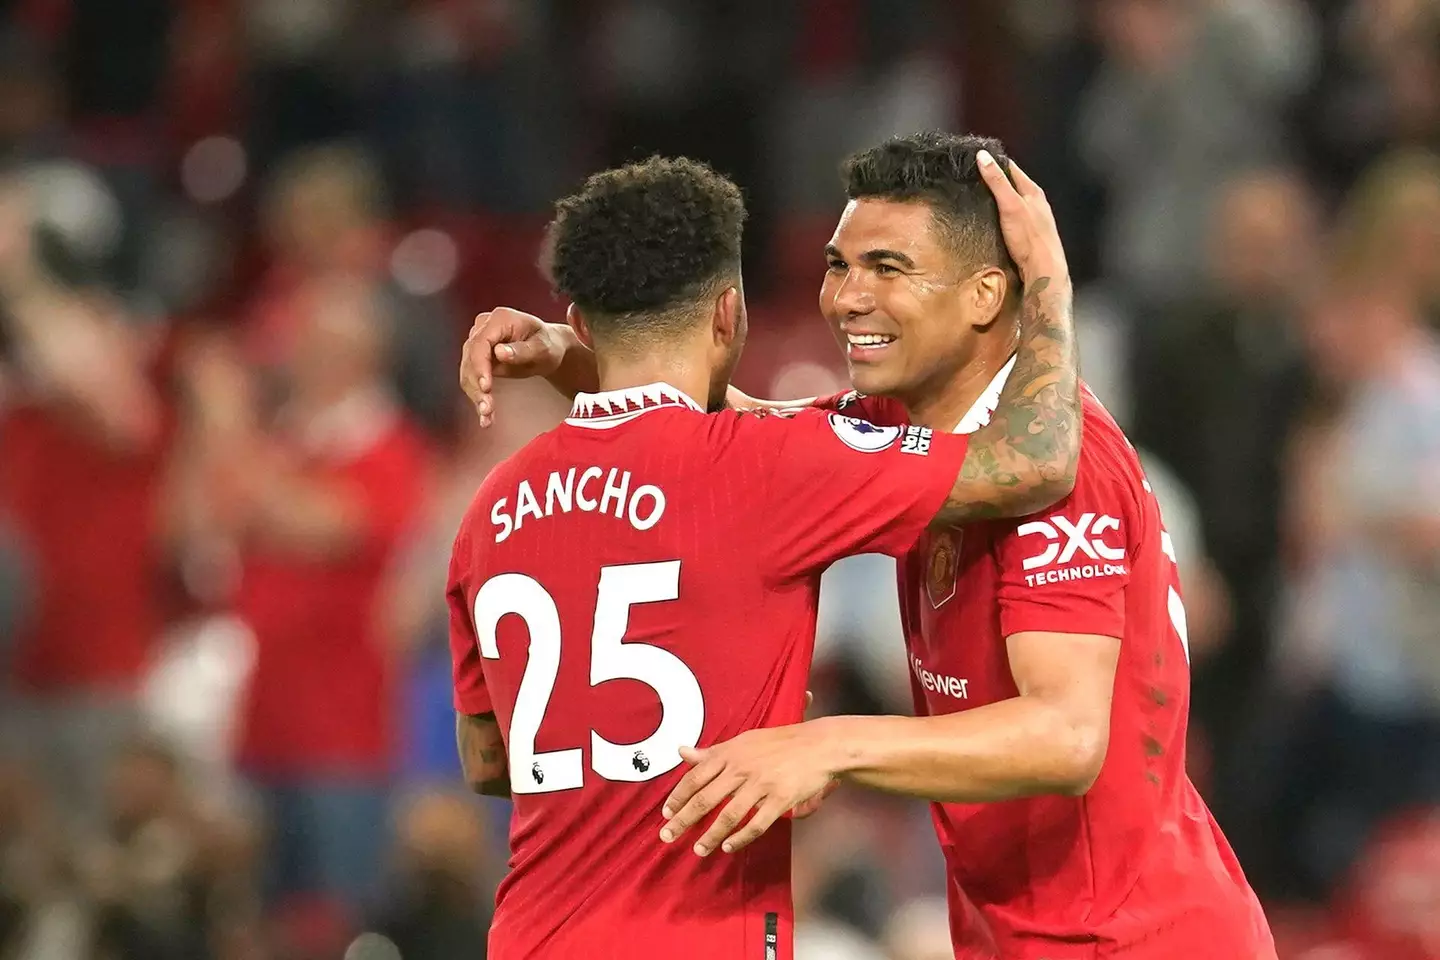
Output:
[{"xmin": 449, "ymin": 384, "xmax": 966, "ymax": 960}]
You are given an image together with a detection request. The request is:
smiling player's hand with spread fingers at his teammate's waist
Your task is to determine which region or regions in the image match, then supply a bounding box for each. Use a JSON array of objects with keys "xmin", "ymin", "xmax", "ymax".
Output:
[{"xmin": 660, "ymin": 721, "xmax": 835, "ymax": 856}]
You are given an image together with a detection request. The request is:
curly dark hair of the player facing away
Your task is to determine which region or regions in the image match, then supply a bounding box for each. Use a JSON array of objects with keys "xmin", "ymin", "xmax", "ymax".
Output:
[{"xmin": 544, "ymin": 157, "xmax": 744, "ymax": 349}]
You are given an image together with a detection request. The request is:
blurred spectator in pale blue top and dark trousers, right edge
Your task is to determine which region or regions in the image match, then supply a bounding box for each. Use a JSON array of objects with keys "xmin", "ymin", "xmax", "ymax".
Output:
[{"xmin": 1260, "ymin": 241, "xmax": 1440, "ymax": 894}]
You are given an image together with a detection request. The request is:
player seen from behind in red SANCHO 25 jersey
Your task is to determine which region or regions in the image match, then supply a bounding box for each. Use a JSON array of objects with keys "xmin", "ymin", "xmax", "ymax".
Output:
[{"xmin": 449, "ymin": 160, "xmax": 1080, "ymax": 960}]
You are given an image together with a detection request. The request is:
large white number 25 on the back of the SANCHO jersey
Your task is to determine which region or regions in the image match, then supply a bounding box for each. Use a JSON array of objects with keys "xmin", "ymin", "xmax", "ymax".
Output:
[{"xmin": 475, "ymin": 560, "xmax": 706, "ymax": 793}]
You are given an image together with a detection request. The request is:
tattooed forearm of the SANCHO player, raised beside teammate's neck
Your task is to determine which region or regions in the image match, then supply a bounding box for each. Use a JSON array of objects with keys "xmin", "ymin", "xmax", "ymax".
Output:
[{"xmin": 936, "ymin": 276, "xmax": 1080, "ymax": 524}]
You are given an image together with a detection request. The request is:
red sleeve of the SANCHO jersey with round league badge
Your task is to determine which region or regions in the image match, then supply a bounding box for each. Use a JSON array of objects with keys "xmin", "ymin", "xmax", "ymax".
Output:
[{"xmin": 724, "ymin": 410, "xmax": 968, "ymax": 579}]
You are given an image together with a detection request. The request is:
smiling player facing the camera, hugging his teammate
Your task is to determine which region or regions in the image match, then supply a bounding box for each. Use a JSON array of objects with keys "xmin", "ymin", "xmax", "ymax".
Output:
[{"xmin": 457, "ymin": 134, "xmax": 1274, "ymax": 960}]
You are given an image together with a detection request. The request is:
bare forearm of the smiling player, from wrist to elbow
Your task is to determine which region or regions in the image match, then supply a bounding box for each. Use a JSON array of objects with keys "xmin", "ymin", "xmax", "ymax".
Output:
[{"xmin": 811, "ymin": 697, "xmax": 1107, "ymax": 803}]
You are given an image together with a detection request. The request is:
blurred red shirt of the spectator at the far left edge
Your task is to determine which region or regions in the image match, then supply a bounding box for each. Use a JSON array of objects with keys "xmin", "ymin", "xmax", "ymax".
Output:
[{"xmin": 0, "ymin": 407, "xmax": 168, "ymax": 694}]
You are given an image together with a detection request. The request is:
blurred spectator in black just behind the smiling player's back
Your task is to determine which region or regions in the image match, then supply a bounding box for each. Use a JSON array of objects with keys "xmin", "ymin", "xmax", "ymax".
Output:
[{"xmin": 1132, "ymin": 168, "xmax": 1320, "ymax": 777}]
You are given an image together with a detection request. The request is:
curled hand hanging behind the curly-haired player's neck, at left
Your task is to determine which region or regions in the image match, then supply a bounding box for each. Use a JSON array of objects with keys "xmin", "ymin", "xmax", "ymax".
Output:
[{"xmin": 459, "ymin": 307, "xmax": 569, "ymax": 426}]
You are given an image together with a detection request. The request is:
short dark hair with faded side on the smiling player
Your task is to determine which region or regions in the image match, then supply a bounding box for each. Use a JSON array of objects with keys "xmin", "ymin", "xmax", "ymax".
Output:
[{"xmin": 841, "ymin": 130, "xmax": 1015, "ymax": 271}]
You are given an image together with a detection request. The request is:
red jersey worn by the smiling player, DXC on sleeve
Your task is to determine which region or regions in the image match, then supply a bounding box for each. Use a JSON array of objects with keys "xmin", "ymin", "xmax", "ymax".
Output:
[{"xmin": 824, "ymin": 382, "xmax": 1274, "ymax": 960}]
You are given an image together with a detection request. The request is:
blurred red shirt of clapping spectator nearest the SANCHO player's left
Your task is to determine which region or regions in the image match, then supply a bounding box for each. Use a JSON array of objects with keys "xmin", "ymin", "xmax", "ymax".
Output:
[{"xmin": 238, "ymin": 416, "xmax": 426, "ymax": 776}]
